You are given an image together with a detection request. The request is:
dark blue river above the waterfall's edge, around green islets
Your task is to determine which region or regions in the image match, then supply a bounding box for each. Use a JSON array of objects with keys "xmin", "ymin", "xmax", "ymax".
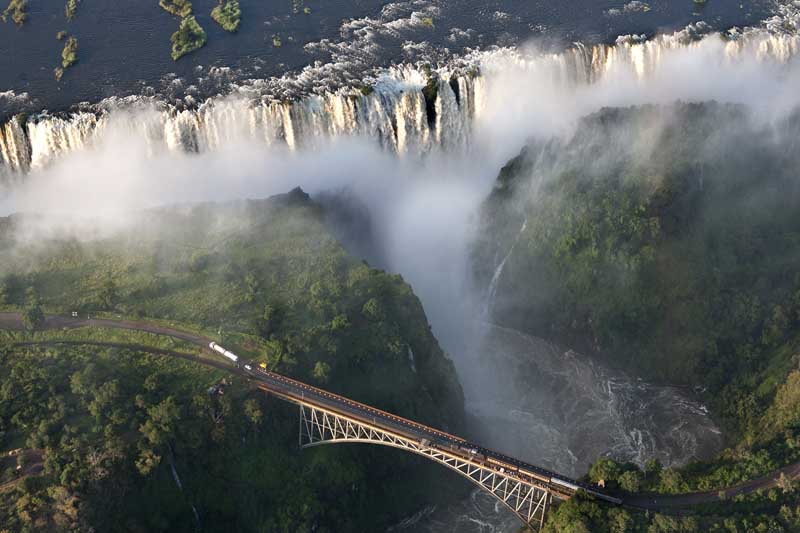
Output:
[{"xmin": 0, "ymin": 0, "xmax": 772, "ymax": 117}]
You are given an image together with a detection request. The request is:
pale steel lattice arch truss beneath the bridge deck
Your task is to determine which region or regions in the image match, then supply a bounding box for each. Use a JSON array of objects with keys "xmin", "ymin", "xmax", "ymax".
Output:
[{"xmin": 299, "ymin": 403, "xmax": 552, "ymax": 529}]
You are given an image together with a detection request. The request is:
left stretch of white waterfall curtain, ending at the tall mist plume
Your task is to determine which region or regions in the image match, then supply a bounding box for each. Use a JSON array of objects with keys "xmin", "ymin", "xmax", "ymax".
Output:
[{"xmin": 0, "ymin": 72, "xmax": 482, "ymax": 181}]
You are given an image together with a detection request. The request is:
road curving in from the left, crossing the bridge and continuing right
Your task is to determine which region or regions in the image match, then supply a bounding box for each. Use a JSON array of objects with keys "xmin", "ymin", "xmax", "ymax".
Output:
[{"xmin": 0, "ymin": 313, "xmax": 800, "ymax": 511}]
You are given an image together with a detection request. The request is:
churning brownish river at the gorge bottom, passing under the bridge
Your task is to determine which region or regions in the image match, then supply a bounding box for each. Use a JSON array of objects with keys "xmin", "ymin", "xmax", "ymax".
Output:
[{"xmin": 392, "ymin": 318, "xmax": 723, "ymax": 533}]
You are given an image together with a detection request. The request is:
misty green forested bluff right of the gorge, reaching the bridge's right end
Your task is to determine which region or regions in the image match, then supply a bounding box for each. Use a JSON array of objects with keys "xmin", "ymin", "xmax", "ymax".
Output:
[{"xmin": 473, "ymin": 103, "xmax": 800, "ymax": 531}]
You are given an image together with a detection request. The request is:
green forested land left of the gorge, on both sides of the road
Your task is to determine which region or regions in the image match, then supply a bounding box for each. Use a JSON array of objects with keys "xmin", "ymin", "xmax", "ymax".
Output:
[{"xmin": 0, "ymin": 186, "xmax": 466, "ymax": 532}]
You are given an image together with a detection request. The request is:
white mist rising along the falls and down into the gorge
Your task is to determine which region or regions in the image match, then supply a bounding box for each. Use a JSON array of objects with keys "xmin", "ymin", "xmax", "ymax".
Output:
[{"xmin": 0, "ymin": 28, "xmax": 800, "ymax": 494}]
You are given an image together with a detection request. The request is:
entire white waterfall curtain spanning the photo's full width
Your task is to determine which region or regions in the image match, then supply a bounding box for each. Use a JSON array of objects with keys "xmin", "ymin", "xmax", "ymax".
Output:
[{"xmin": 0, "ymin": 23, "xmax": 800, "ymax": 184}]
